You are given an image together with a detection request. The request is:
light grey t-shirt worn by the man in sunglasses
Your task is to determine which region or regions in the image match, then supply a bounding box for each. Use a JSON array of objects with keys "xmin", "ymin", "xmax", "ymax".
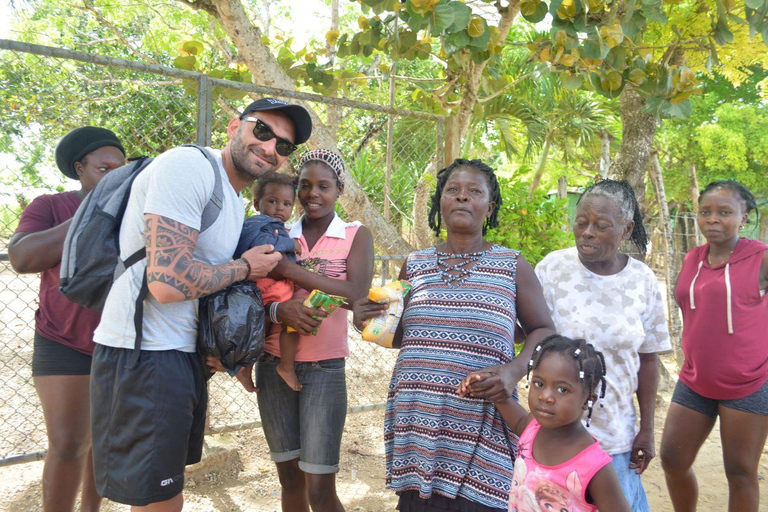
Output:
[{"xmin": 93, "ymin": 147, "xmax": 245, "ymax": 352}]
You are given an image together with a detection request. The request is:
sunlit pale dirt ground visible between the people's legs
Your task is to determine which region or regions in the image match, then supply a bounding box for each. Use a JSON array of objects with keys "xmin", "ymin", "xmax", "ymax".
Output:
[{"xmin": 0, "ymin": 358, "xmax": 768, "ymax": 512}]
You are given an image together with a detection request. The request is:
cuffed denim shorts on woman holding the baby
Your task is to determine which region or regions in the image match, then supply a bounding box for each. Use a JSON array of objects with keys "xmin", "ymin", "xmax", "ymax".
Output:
[{"xmin": 256, "ymin": 354, "xmax": 347, "ymax": 475}]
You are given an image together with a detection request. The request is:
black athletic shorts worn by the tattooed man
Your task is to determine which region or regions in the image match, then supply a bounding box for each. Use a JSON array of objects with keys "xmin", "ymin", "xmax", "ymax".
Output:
[{"xmin": 91, "ymin": 344, "xmax": 208, "ymax": 506}]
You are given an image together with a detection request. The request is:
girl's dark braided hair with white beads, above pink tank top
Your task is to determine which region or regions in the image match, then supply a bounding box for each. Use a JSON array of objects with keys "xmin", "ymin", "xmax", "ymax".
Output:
[{"xmin": 525, "ymin": 334, "xmax": 607, "ymax": 426}]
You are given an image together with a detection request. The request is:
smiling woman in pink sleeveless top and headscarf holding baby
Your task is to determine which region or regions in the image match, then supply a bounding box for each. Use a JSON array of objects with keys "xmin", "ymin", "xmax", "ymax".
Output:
[{"xmin": 241, "ymin": 149, "xmax": 373, "ymax": 512}]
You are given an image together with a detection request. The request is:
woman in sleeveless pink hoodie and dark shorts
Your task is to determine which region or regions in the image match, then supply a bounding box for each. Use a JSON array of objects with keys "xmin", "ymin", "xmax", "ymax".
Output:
[{"xmin": 661, "ymin": 181, "xmax": 768, "ymax": 512}]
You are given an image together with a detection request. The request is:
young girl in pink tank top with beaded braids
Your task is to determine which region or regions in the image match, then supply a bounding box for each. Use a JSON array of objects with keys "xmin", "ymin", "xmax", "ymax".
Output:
[{"xmin": 457, "ymin": 334, "xmax": 630, "ymax": 512}]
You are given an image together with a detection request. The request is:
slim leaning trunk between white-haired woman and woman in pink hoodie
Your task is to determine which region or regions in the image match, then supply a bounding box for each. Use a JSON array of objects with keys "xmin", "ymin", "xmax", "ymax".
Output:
[{"xmin": 649, "ymin": 150, "xmax": 683, "ymax": 367}]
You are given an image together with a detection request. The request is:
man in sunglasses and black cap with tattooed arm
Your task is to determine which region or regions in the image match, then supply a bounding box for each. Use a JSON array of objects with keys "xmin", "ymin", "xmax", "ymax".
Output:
[{"xmin": 91, "ymin": 98, "xmax": 312, "ymax": 512}]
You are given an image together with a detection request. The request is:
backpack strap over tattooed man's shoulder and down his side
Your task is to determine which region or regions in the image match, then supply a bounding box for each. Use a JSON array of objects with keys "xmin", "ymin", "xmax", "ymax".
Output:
[{"xmin": 123, "ymin": 144, "xmax": 224, "ymax": 370}]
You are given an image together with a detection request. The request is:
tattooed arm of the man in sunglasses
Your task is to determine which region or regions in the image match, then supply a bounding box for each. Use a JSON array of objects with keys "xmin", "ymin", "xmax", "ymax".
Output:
[{"xmin": 144, "ymin": 214, "xmax": 248, "ymax": 304}]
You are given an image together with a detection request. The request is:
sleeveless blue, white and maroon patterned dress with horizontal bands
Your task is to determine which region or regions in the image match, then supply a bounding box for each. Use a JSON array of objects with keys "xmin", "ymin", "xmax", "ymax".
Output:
[{"xmin": 384, "ymin": 245, "xmax": 520, "ymax": 509}]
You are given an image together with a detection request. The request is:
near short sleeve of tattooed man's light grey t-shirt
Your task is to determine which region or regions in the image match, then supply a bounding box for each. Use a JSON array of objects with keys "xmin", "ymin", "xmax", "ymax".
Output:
[{"xmin": 144, "ymin": 147, "xmax": 218, "ymax": 231}]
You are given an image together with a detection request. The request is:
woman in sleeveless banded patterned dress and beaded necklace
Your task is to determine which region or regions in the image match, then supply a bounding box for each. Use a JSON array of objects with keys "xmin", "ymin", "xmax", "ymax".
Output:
[{"xmin": 353, "ymin": 159, "xmax": 554, "ymax": 512}]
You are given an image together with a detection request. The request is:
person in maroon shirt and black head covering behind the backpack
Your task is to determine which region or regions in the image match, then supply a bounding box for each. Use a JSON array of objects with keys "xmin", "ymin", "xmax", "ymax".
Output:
[{"xmin": 8, "ymin": 126, "xmax": 125, "ymax": 512}]
